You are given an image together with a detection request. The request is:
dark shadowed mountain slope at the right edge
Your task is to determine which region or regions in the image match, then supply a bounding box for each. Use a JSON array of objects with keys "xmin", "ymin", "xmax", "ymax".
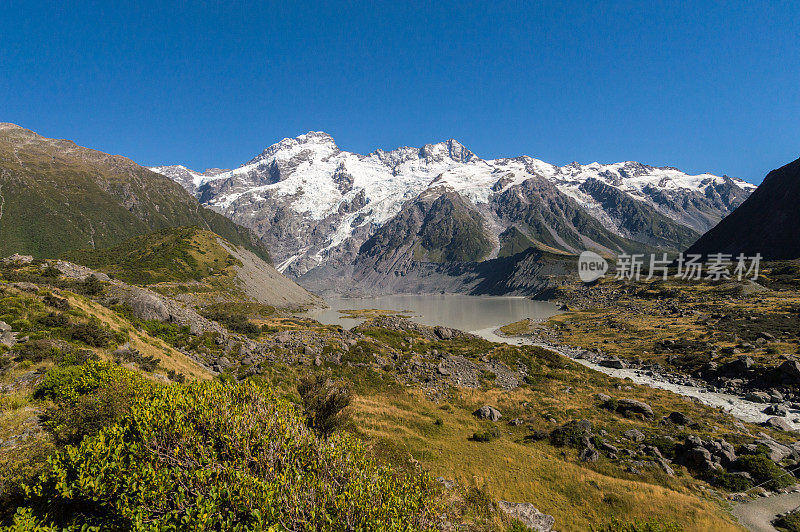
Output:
[{"xmin": 688, "ymin": 159, "xmax": 800, "ymax": 260}]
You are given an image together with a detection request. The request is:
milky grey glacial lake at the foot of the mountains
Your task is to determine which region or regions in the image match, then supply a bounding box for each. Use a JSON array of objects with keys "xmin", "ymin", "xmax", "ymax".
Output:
[{"xmin": 304, "ymin": 294, "xmax": 559, "ymax": 339}]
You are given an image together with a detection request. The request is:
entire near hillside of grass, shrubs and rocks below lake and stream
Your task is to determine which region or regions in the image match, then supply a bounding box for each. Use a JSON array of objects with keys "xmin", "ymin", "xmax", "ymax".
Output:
[{"xmin": 0, "ymin": 256, "xmax": 791, "ymax": 532}]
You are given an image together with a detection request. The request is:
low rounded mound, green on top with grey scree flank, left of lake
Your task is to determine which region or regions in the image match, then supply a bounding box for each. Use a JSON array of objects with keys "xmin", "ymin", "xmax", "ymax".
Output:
[{"xmin": 64, "ymin": 227, "xmax": 321, "ymax": 308}]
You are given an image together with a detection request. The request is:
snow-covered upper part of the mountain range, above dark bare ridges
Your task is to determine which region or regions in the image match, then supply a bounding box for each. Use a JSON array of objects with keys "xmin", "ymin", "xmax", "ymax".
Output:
[{"xmin": 152, "ymin": 131, "xmax": 755, "ymax": 275}]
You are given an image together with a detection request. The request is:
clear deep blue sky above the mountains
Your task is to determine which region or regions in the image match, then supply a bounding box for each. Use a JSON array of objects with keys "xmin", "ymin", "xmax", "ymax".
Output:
[{"xmin": 0, "ymin": 0, "xmax": 800, "ymax": 183}]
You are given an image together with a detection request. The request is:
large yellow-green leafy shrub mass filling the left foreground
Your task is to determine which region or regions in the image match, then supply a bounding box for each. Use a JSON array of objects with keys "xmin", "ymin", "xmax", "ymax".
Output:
[{"xmin": 12, "ymin": 376, "xmax": 440, "ymax": 531}]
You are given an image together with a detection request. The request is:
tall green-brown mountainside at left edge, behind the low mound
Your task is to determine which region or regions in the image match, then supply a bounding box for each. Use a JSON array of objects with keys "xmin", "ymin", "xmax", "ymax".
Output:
[{"xmin": 0, "ymin": 124, "xmax": 270, "ymax": 260}]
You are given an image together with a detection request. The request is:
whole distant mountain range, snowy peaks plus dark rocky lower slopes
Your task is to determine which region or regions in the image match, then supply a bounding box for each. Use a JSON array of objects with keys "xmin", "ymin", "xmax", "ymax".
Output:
[{"xmin": 151, "ymin": 132, "xmax": 756, "ymax": 291}]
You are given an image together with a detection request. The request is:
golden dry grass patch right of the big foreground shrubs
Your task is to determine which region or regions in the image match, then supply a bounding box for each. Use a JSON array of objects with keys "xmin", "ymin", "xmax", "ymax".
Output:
[{"xmin": 353, "ymin": 390, "xmax": 742, "ymax": 531}]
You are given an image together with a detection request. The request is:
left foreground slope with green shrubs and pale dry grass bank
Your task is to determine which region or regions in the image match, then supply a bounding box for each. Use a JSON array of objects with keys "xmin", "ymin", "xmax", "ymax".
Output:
[{"xmin": 0, "ymin": 263, "xmax": 439, "ymax": 531}]
